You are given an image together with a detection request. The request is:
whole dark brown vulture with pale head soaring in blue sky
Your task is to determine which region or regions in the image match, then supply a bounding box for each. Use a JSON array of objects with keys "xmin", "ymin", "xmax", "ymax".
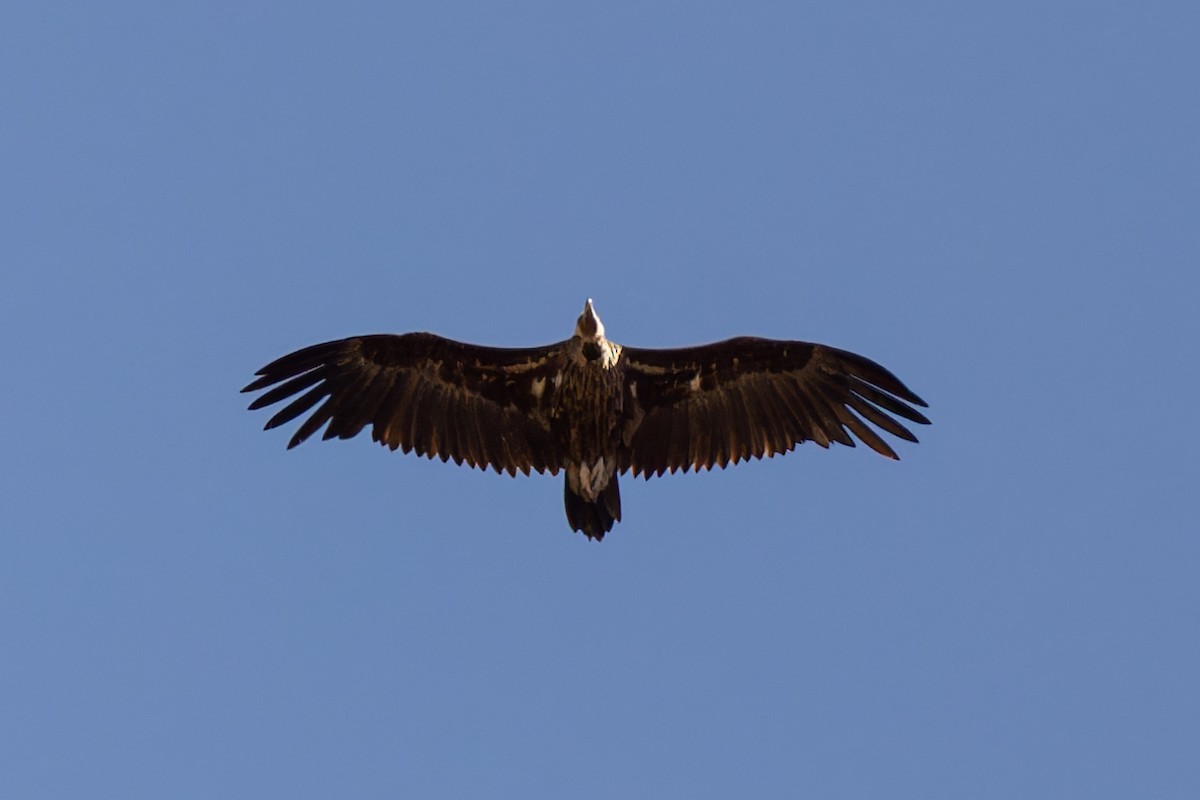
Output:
[{"xmin": 242, "ymin": 300, "xmax": 929, "ymax": 540}]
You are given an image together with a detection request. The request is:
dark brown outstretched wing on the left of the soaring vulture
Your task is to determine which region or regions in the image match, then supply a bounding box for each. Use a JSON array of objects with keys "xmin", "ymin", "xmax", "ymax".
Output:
[{"xmin": 242, "ymin": 333, "xmax": 571, "ymax": 475}]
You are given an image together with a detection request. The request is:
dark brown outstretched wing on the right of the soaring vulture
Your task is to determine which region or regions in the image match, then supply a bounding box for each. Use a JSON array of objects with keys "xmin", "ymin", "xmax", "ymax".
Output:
[{"xmin": 620, "ymin": 337, "xmax": 929, "ymax": 479}]
